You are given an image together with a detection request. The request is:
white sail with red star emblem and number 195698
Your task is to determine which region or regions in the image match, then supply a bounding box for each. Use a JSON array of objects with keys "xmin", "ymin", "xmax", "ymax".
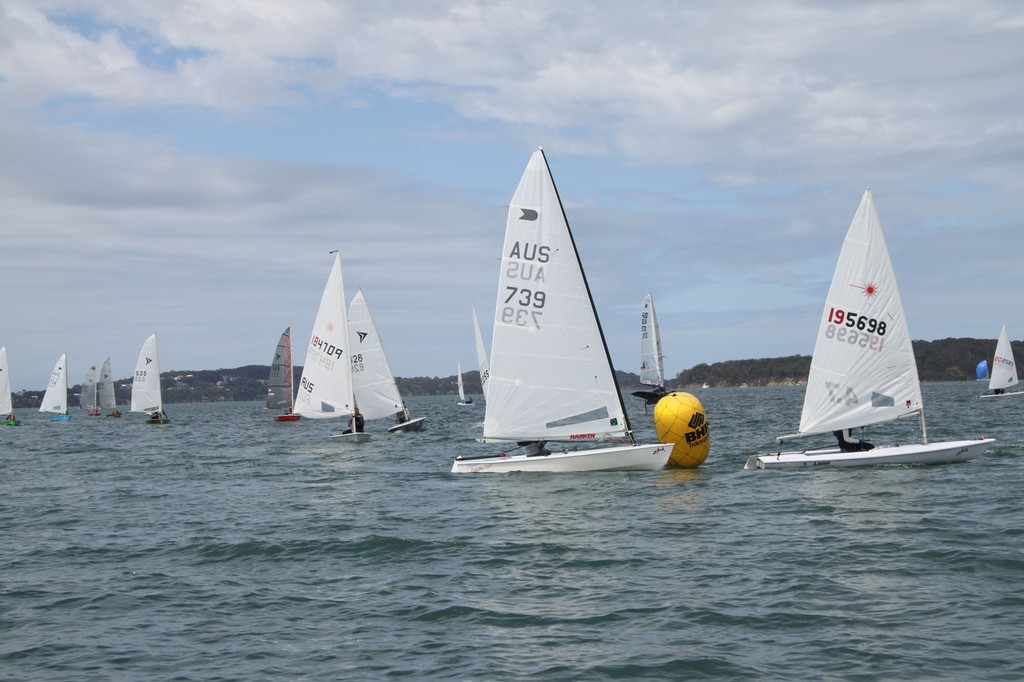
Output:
[{"xmin": 800, "ymin": 188, "xmax": 923, "ymax": 434}]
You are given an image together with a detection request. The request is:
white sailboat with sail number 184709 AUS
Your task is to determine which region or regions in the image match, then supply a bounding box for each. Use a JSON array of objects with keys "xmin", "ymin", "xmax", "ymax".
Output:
[{"xmin": 295, "ymin": 250, "xmax": 370, "ymax": 442}]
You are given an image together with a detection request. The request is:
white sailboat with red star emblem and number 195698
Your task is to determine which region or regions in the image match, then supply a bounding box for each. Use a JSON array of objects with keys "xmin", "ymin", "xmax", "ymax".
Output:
[{"xmin": 744, "ymin": 187, "xmax": 994, "ymax": 469}]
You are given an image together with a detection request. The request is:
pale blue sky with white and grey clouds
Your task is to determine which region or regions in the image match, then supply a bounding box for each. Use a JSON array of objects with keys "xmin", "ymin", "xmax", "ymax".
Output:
[{"xmin": 0, "ymin": 0, "xmax": 1024, "ymax": 390}]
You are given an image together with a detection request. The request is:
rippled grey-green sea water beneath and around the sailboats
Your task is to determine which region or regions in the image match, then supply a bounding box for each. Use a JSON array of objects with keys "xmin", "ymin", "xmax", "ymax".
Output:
[{"xmin": 0, "ymin": 382, "xmax": 1024, "ymax": 681}]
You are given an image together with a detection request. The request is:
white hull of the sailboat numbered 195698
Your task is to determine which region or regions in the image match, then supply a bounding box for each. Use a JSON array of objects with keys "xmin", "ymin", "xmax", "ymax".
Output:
[{"xmin": 743, "ymin": 438, "xmax": 995, "ymax": 469}]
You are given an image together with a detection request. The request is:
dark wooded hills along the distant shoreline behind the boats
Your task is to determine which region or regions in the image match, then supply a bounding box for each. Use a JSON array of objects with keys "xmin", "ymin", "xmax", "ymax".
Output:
[{"xmin": 8, "ymin": 339, "xmax": 1024, "ymax": 409}]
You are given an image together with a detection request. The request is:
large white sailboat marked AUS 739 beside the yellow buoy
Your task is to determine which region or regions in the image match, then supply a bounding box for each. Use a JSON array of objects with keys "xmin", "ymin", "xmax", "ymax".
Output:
[{"xmin": 452, "ymin": 150, "xmax": 673, "ymax": 473}]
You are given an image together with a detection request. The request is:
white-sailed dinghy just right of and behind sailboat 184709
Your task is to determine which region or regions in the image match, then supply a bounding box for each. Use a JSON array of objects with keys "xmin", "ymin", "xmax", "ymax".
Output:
[{"xmin": 348, "ymin": 289, "xmax": 426, "ymax": 433}]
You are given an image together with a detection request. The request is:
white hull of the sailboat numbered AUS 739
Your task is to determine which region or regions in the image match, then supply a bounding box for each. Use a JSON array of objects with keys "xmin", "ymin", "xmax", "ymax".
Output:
[{"xmin": 452, "ymin": 443, "xmax": 672, "ymax": 473}]
